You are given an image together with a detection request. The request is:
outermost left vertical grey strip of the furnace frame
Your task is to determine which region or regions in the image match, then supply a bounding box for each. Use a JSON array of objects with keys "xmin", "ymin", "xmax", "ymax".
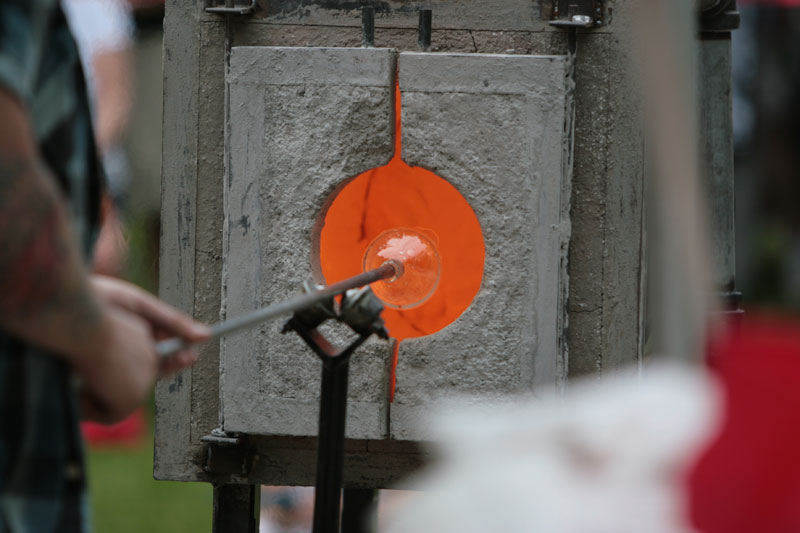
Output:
[{"xmin": 153, "ymin": 2, "xmax": 201, "ymax": 479}]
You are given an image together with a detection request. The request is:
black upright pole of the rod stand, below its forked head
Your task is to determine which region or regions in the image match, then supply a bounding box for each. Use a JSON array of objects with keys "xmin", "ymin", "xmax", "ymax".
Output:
[{"xmin": 314, "ymin": 357, "xmax": 349, "ymax": 533}]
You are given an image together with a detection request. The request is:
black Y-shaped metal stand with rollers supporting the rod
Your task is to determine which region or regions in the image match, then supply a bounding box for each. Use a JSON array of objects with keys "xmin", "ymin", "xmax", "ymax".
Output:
[{"xmin": 283, "ymin": 287, "xmax": 389, "ymax": 533}]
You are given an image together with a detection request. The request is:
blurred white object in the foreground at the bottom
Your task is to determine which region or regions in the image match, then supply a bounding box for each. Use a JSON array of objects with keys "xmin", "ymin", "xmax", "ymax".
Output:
[{"xmin": 387, "ymin": 364, "xmax": 722, "ymax": 533}]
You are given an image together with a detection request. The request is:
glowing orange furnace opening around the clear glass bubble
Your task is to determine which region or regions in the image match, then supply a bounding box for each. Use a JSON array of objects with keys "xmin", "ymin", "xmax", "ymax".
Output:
[{"xmin": 319, "ymin": 82, "xmax": 484, "ymax": 341}]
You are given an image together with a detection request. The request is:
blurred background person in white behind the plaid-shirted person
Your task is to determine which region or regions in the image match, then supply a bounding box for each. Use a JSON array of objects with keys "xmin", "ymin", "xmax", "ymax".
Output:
[{"xmin": 61, "ymin": 0, "xmax": 134, "ymax": 276}]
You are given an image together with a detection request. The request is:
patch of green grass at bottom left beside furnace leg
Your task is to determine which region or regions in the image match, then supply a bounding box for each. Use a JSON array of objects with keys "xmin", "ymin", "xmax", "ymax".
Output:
[{"xmin": 87, "ymin": 408, "xmax": 212, "ymax": 533}]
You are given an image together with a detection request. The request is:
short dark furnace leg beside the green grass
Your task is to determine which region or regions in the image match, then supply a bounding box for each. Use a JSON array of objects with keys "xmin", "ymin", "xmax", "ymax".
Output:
[{"xmin": 211, "ymin": 485, "xmax": 261, "ymax": 533}]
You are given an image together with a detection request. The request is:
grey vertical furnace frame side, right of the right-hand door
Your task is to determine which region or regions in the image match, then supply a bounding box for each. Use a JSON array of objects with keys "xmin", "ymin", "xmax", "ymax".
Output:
[{"xmin": 567, "ymin": 21, "xmax": 644, "ymax": 378}]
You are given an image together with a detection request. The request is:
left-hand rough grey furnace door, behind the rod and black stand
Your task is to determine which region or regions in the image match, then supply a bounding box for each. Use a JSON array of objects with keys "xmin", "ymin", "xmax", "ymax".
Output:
[{"xmin": 220, "ymin": 47, "xmax": 395, "ymax": 439}]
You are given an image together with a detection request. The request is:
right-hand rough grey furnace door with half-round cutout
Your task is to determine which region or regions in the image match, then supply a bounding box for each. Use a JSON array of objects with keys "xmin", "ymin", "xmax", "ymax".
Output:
[{"xmin": 390, "ymin": 53, "xmax": 569, "ymax": 441}]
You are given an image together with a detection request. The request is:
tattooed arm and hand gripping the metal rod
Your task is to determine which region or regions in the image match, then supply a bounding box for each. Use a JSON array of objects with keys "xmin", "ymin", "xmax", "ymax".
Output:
[{"xmin": 0, "ymin": 89, "xmax": 206, "ymax": 420}]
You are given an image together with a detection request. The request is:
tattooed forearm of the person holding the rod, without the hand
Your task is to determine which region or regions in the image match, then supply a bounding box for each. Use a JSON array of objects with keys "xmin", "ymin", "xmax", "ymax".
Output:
[{"xmin": 0, "ymin": 91, "xmax": 104, "ymax": 357}]
